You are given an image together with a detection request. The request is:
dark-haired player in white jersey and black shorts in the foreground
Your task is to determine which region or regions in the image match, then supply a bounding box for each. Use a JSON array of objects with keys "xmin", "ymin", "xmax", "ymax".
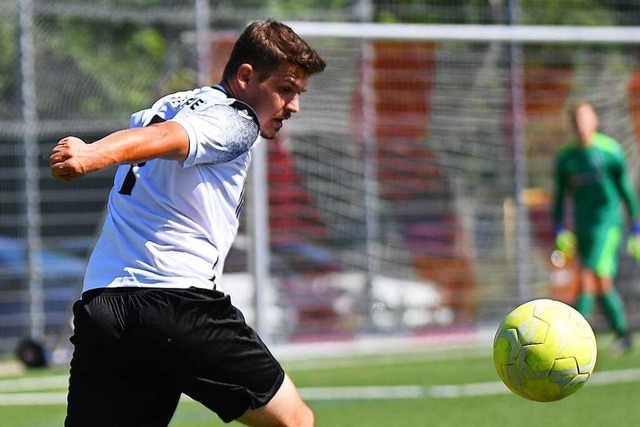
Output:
[{"xmin": 49, "ymin": 20, "xmax": 325, "ymax": 427}]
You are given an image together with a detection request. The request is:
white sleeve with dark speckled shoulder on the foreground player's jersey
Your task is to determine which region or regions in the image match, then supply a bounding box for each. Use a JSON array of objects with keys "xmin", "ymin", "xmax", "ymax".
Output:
[{"xmin": 172, "ymin": 101, "xmax": 260, "ymax": 167}]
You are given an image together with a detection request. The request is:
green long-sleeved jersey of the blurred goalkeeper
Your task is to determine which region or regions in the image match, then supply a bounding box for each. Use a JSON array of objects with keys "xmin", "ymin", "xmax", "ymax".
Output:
[{"xmin": 553, "ymin": 133, "xmax": 638, "ymax": 235}]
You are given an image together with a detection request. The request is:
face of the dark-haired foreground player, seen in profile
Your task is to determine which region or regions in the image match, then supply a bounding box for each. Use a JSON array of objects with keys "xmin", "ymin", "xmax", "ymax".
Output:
[{"xmin": 247, "ymin": 65, "xmax": 307, "ymax": 139}]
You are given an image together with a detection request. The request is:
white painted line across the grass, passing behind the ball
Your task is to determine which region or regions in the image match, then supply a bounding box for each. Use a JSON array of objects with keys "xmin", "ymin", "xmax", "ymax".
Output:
[{"xmin": 0, "ymin": 368, "xmax": 640, "ymax": 406}]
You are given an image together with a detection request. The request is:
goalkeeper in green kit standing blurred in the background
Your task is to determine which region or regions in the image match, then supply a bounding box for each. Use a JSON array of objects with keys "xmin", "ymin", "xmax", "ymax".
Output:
[{"xmin": 553, "ymin": 102, "xmax": 640, "ymax": 351}]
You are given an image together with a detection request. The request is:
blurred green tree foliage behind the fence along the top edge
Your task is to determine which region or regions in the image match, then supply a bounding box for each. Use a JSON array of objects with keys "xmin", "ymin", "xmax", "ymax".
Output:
[{"xmin": 0, "ymin": 0, "xmax": 640, "ymax": 123}]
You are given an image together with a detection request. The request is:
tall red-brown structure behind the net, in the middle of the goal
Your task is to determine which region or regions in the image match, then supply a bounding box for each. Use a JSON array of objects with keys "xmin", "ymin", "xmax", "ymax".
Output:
[{"xmin": 352, "ymin": 41, "xmax": 475, "ymax": 320}]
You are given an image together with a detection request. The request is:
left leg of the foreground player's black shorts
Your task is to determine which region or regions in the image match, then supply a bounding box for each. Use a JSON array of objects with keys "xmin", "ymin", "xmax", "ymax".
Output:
[{"xmin": 65, "ymin": 295, "xmax": 180, "ymax": 427}]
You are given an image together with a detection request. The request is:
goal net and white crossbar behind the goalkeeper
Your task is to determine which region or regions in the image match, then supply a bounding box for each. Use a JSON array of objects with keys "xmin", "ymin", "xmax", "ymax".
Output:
[{"xmin": 229, "ymin": 22, "xmax": 640, "ymax": 344}]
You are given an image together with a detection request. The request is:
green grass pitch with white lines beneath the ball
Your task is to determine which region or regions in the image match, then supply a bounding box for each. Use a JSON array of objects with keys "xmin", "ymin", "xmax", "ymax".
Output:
[{"xmin": 0, "ymin": 336, "xmax": 640, "ymax": 427}]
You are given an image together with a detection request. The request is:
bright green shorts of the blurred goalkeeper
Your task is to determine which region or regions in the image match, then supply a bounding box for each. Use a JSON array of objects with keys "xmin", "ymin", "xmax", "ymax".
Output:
[{"xmin": 576, "ymin": 225, "xmax": 622, "ymax": 278}]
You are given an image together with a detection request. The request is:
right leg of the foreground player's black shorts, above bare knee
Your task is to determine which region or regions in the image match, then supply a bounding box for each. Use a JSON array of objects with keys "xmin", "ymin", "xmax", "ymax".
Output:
[{"xmin": 172, "ymin": 289, "xmax": 285, "ymax": 422}]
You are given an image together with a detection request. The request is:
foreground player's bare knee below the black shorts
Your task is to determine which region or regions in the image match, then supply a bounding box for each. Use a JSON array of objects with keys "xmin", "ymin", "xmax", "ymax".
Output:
[{"xmin": 236, "ymin": 376, "xmax": 314, "ymax": 427}]
